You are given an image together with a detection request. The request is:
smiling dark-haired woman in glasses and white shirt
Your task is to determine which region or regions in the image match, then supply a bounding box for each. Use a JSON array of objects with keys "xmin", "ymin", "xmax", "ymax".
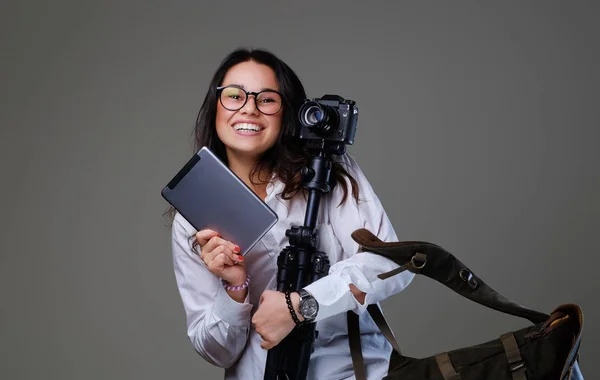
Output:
[{"xmin": 172, "ymin": 49, "xmax": 413, "ymax": 379}]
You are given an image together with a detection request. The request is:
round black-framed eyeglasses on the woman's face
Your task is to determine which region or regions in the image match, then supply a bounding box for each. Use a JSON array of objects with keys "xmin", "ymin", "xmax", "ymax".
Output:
[{"xmin": 217, "ymin": 86, "xmax": 283, "ymax": 115}]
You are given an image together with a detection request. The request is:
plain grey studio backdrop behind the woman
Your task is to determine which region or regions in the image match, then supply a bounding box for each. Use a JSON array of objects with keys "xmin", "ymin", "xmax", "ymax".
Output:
[{"xmin": 0, "ymin": 1, "xmax": 600, "ymax": 380}]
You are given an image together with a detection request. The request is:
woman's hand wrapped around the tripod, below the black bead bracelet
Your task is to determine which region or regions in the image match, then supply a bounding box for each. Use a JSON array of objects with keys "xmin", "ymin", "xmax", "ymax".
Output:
[{"xmin": 252, "ymin": 290, "xmax": 303, "ymax": 350}]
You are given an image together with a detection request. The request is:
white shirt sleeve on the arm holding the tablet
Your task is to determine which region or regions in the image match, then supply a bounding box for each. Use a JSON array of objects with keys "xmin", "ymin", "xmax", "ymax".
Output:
[{"xmin": 172, "ymin": 214, "xmax": 252, "ymax": 368}]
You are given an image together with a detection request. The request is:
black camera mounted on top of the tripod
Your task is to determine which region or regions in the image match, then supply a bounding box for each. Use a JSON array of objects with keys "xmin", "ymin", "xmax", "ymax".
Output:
[{"xmin": 296, "ymin": 95, "xmax": 358, "ymax": 145}]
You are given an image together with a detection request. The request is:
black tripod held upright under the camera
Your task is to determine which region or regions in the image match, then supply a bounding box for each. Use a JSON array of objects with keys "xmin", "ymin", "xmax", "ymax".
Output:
[{"xmin": 264, "ymin": 140, "xmax": 346, "ymax": 380}]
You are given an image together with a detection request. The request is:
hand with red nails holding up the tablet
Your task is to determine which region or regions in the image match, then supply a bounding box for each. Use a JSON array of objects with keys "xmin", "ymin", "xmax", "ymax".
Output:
[{"xmin": 196, "ymin": 229, "xmax": 246, "ymax": 286}]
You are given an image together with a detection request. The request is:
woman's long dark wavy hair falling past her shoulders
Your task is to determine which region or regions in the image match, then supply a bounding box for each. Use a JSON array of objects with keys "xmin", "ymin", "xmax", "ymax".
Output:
[{"xmin": 164, "ymin": 48, "xmax": 359, "ymax": 224}]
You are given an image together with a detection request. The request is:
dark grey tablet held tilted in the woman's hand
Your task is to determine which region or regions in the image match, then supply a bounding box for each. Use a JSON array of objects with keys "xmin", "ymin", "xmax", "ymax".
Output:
[{"xmin": 161, "ymin": 147, "xmax": 278, "ymax": 255}]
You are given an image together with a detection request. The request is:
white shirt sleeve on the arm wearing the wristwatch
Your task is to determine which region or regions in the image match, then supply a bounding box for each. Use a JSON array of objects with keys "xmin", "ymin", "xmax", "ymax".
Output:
[{"xmin": 305, "ymin": 154, "xmax": 414, "ymax": 321}]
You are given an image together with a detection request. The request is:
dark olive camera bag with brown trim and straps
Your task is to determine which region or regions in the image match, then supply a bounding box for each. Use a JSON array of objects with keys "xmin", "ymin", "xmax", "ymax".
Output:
[{"xmin": 347, "ymin": 229, "xmax": 583, "ymax": 380}]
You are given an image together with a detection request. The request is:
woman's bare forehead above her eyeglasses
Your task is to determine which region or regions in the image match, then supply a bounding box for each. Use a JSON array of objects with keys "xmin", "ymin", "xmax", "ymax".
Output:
[{"xmin": 222, "ymin": 61, "xmax": 279, "ymax": 91}]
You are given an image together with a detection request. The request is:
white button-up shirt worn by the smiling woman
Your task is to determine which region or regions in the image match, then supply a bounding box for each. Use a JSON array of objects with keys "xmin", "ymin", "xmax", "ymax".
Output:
[{"xmin": 172, "ymin": 154, "xmax": 414, "ymax": 379}]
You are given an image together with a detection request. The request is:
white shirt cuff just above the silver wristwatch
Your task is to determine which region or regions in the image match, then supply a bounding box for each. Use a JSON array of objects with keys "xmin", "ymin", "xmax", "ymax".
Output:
[{"xmin": 304, "ymin": 272, "xmax": 366, "ymax": 322}]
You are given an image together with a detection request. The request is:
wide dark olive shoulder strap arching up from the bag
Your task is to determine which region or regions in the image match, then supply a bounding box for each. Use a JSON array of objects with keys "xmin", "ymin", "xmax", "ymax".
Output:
[{"xmin": 351, "ymin": 228, "xmax": 549, "ymax": 324}]
